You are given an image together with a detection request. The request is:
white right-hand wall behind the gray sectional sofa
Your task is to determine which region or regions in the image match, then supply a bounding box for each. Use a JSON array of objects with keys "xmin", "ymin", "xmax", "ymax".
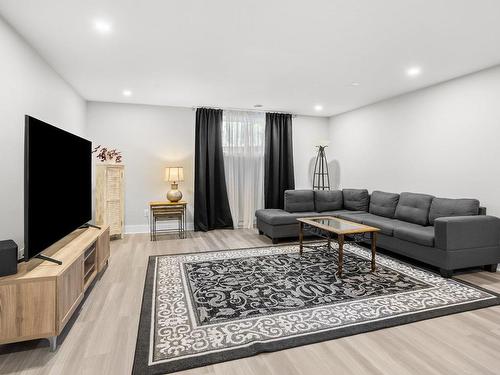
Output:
[{"xmin": 330, "ymin": 67, "xmax": 500, "ymax": 215}]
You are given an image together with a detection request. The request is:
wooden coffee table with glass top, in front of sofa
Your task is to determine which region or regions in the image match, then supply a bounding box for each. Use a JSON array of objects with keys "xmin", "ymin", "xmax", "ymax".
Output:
[{"xmin": 297, "ymin": 216, "xmax": 380, "ymax": 277}]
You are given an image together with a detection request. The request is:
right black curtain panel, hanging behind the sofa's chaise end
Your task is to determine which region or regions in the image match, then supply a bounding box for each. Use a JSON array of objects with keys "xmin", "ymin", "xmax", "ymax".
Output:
[{"xmin": 264, "ymin": 113, "xmax": 295, "ymax": 208}]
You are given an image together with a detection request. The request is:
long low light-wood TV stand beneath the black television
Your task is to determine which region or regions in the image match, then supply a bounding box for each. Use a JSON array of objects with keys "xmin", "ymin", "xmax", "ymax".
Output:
[{"xmin": 0, "ymin": 227, "xmax": 109, "ymax": 350}]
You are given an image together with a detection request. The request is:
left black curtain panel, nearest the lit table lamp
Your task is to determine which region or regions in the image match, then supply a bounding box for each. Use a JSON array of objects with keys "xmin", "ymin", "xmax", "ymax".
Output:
[{"xmin": 194, "ymin": 108, "xmax": 233, "ymax": 231}]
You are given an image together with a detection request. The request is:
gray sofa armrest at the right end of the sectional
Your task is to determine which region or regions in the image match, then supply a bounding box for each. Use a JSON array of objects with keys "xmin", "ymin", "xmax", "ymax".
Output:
[{"xmin": 434, "ymin": 215, "xmax": 500, "ymax": 250}]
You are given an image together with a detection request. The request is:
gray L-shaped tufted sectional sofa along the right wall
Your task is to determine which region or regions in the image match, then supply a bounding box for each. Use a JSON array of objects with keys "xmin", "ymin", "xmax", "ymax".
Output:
[{"xmin": 255, "ymin": 189, "xmax": 500, "ymax": 277}]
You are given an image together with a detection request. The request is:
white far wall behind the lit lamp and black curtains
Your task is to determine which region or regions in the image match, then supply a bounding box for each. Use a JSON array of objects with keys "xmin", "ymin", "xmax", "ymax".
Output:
[{"xmin": 87, "ymin": 102, "xmax": 328, "ymax": 233}]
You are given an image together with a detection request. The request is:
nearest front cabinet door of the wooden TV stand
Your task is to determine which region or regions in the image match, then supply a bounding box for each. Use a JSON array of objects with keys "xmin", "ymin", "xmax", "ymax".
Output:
[{"xmin": 57, "ymin": 254, "xmax": 84, "ymax": 333}]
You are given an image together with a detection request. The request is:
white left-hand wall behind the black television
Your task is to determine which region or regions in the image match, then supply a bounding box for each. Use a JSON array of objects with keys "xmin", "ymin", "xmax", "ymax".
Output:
[{"xmin": 0, "ymin": 18, "xmax": 86, "ymax": 253}]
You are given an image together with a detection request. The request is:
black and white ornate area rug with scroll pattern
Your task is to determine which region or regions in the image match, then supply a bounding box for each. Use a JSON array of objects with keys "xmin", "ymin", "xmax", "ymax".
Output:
[{"xmin": 133, "ymin": 243, "xmax": 500, "ymax": 374}]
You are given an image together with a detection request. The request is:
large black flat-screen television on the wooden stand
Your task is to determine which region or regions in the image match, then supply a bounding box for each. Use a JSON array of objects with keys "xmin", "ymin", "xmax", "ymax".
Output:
[{"xmin": 24, "ymin": 116, "xmax": 92, "ymax": 260}]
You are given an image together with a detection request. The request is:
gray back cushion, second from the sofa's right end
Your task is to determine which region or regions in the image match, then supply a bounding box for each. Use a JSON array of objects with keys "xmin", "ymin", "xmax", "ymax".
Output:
[{"xmin": 394, "ymin": 193, "xmax": 434, "ymax": 225}]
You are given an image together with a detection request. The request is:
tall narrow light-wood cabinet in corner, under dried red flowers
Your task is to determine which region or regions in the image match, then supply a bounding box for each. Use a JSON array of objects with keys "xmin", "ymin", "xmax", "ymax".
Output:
[{"xmin": 95, "ymin": 164, "xmax": 125, "ymax": 238}]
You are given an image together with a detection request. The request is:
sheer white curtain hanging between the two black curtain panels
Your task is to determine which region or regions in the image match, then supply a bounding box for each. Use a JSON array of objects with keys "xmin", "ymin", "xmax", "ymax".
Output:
[{"xmin": 222, "ymin": 111, "xmax": 266, "ymax": 228}]
